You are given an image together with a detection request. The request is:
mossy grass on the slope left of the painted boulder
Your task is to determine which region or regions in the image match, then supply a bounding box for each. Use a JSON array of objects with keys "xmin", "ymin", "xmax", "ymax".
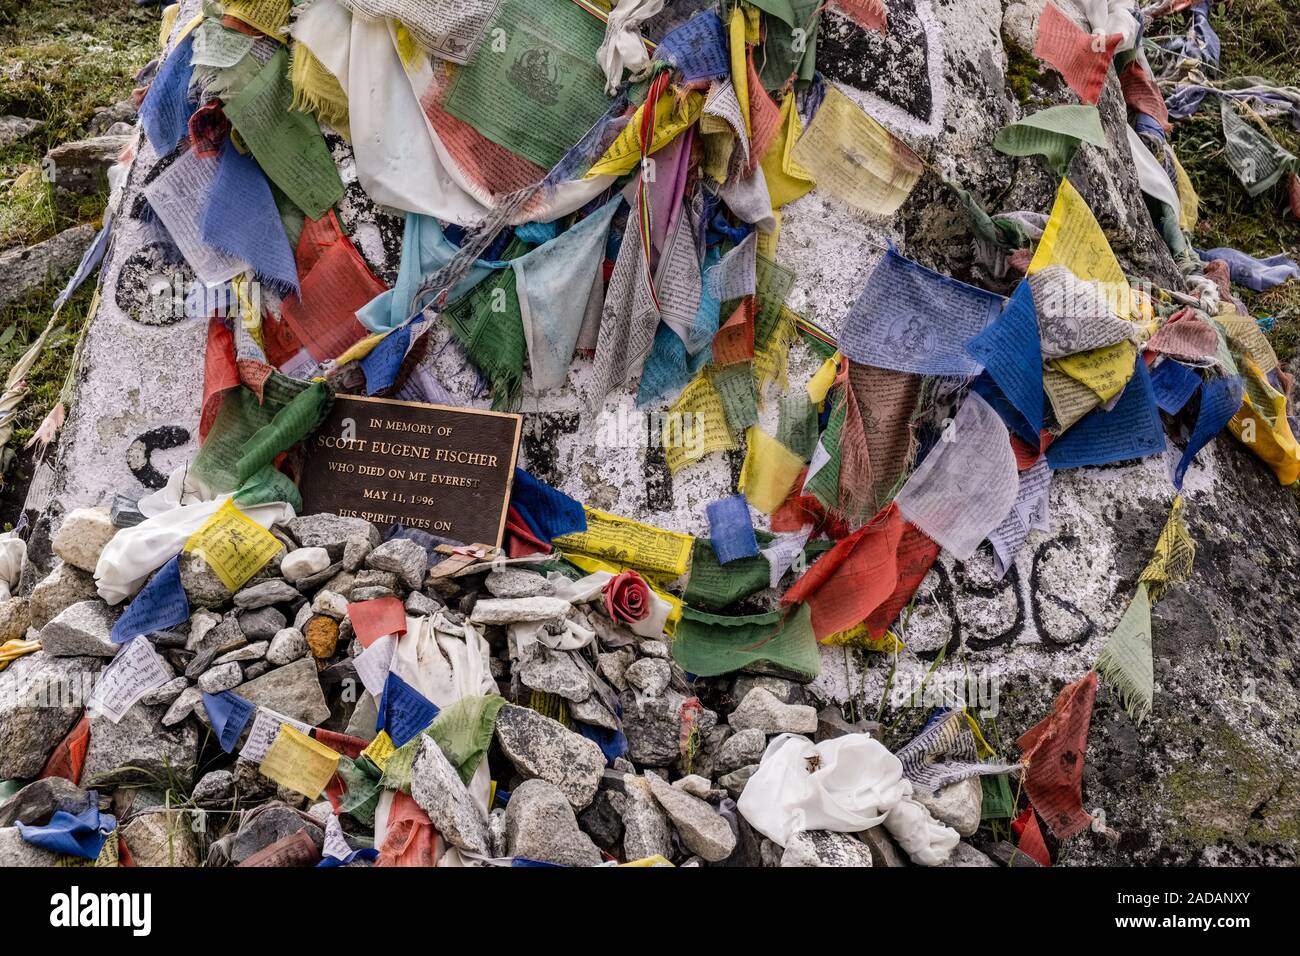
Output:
[{"xmin": 0, "ymin": 0, "xmax": 159, "ymax": 515}]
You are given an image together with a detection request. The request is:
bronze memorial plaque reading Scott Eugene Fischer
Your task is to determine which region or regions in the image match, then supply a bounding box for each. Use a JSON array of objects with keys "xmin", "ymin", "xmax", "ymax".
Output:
[{"xmin": 300, "ymin": 395, "xmax": 524, "ymax": 548}]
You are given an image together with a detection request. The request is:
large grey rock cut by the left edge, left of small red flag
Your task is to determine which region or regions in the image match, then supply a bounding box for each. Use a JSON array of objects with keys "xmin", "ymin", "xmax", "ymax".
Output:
[{"xmin": 0, "ymin": 652, "xmax": 103, "ymax": 779}]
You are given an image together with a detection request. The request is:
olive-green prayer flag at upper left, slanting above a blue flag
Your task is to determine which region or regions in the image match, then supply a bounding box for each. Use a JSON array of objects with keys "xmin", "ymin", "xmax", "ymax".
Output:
[{"xmin": 225, "ymin": 48, "xmax": 343, "ymax": 219}]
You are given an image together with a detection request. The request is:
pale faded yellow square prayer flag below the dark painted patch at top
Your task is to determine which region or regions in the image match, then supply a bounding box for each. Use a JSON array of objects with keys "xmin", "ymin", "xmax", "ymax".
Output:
[{"xmin": 785, "ymin": 86, "xmax": 926, "ymax": 216}]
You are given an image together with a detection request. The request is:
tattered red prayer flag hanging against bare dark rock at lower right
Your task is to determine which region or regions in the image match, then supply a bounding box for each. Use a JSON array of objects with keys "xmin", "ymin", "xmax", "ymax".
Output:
[{"xmin": 1017, "ymin": 671, "xmax": 1097, "ymax": 840}]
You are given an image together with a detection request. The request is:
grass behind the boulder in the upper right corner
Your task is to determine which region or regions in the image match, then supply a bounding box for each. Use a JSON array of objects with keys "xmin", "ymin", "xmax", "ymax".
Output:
[{"xmin": 1156, "ymin": 0, "xmax": 1300, "ymax": 363}]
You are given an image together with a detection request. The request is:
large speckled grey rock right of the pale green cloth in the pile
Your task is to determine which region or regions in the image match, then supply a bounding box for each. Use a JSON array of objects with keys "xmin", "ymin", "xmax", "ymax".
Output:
[{"xmin": 497, "ymin": 704, "xmax": 605, "ymax": 809}]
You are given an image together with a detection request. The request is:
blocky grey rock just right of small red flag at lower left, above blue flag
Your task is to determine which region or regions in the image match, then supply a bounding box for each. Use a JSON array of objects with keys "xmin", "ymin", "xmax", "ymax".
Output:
[{"xmin": 82, "ymin": 698, "xmax": 199, "ymax": 787}]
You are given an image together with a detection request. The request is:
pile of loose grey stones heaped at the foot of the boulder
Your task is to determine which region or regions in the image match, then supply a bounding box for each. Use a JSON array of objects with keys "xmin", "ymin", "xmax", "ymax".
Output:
[{"xmin": 0, "ymin": 510, "xmax": 998, "ymax": 866}]
